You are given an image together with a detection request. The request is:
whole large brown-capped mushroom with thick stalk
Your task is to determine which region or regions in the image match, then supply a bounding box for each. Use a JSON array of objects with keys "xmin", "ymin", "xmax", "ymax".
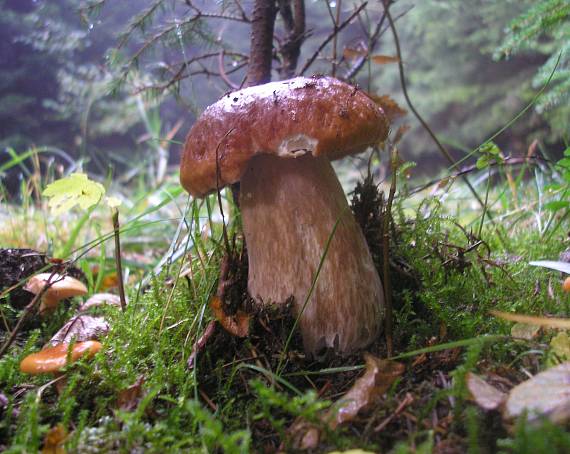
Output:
[{"xmin": 180, "ymin": 77, "xmax": 388, "ymax": 355}]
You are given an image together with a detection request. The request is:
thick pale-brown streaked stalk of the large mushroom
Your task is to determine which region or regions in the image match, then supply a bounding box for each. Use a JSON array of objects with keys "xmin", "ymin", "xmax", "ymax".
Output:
[{"xmin": 240, "ymin": 154, "xmax": 384, "ymax": 355}]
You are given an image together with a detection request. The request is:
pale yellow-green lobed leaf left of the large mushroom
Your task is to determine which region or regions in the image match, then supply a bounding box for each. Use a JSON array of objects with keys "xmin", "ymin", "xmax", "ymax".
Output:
[{"xmin": 42, "ymin": 173, "xmax": 105, "ymax": 214}]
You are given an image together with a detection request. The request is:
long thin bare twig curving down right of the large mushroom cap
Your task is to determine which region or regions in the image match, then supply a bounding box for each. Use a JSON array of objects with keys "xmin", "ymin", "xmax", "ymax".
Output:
[{"xmin": 383, "ymin": 0, "xmax": 506, "ymax": 248}]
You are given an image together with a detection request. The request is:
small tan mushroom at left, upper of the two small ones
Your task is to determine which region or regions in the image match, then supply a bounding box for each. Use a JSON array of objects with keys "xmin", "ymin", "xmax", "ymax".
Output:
[{"xmin": 24, "ymin": 273, "xmax": 87, "ymax": 314}]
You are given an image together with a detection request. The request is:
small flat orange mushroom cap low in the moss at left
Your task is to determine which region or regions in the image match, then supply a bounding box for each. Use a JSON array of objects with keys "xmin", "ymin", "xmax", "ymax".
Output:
[{"xmin": 20, "ymin": 341, "xmax": 102, "ymax": 375}]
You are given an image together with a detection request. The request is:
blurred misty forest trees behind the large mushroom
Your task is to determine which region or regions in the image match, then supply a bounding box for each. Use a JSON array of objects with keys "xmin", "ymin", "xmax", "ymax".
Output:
[{"xmin": 0, "ymin": 0, "xmax": 570, "ymax": 192}]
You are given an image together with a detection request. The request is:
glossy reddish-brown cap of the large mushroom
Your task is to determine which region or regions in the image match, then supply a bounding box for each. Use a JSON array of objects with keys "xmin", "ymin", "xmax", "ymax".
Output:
[{"xmin": 180, "ymin": 77, "xmax": 388, "ymax": 196}]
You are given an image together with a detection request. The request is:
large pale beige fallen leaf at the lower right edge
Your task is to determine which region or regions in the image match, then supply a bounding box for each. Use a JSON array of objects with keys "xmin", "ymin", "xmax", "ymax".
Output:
[{"xmin": 503, "ymin": 362, "xmax": 570, "ymax": 423}]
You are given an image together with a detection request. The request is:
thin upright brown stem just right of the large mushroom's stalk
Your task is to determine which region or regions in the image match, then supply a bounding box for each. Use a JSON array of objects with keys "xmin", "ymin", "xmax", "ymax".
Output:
[{"xmin": 382, "ymin": 146, "xmax": 398, "ymax": 357}]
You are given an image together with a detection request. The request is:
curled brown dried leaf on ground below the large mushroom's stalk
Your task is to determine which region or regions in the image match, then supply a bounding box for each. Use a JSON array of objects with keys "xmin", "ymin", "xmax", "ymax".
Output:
[{"xmin": 327, "ymin": 353, "xmax": 405, "ymax": 429}]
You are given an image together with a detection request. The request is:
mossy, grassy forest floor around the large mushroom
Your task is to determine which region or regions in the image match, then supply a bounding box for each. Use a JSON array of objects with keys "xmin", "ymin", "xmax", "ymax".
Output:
[{"xmin": 0, "ymin": 155, "xmax": 570, "ymax": 453}]
